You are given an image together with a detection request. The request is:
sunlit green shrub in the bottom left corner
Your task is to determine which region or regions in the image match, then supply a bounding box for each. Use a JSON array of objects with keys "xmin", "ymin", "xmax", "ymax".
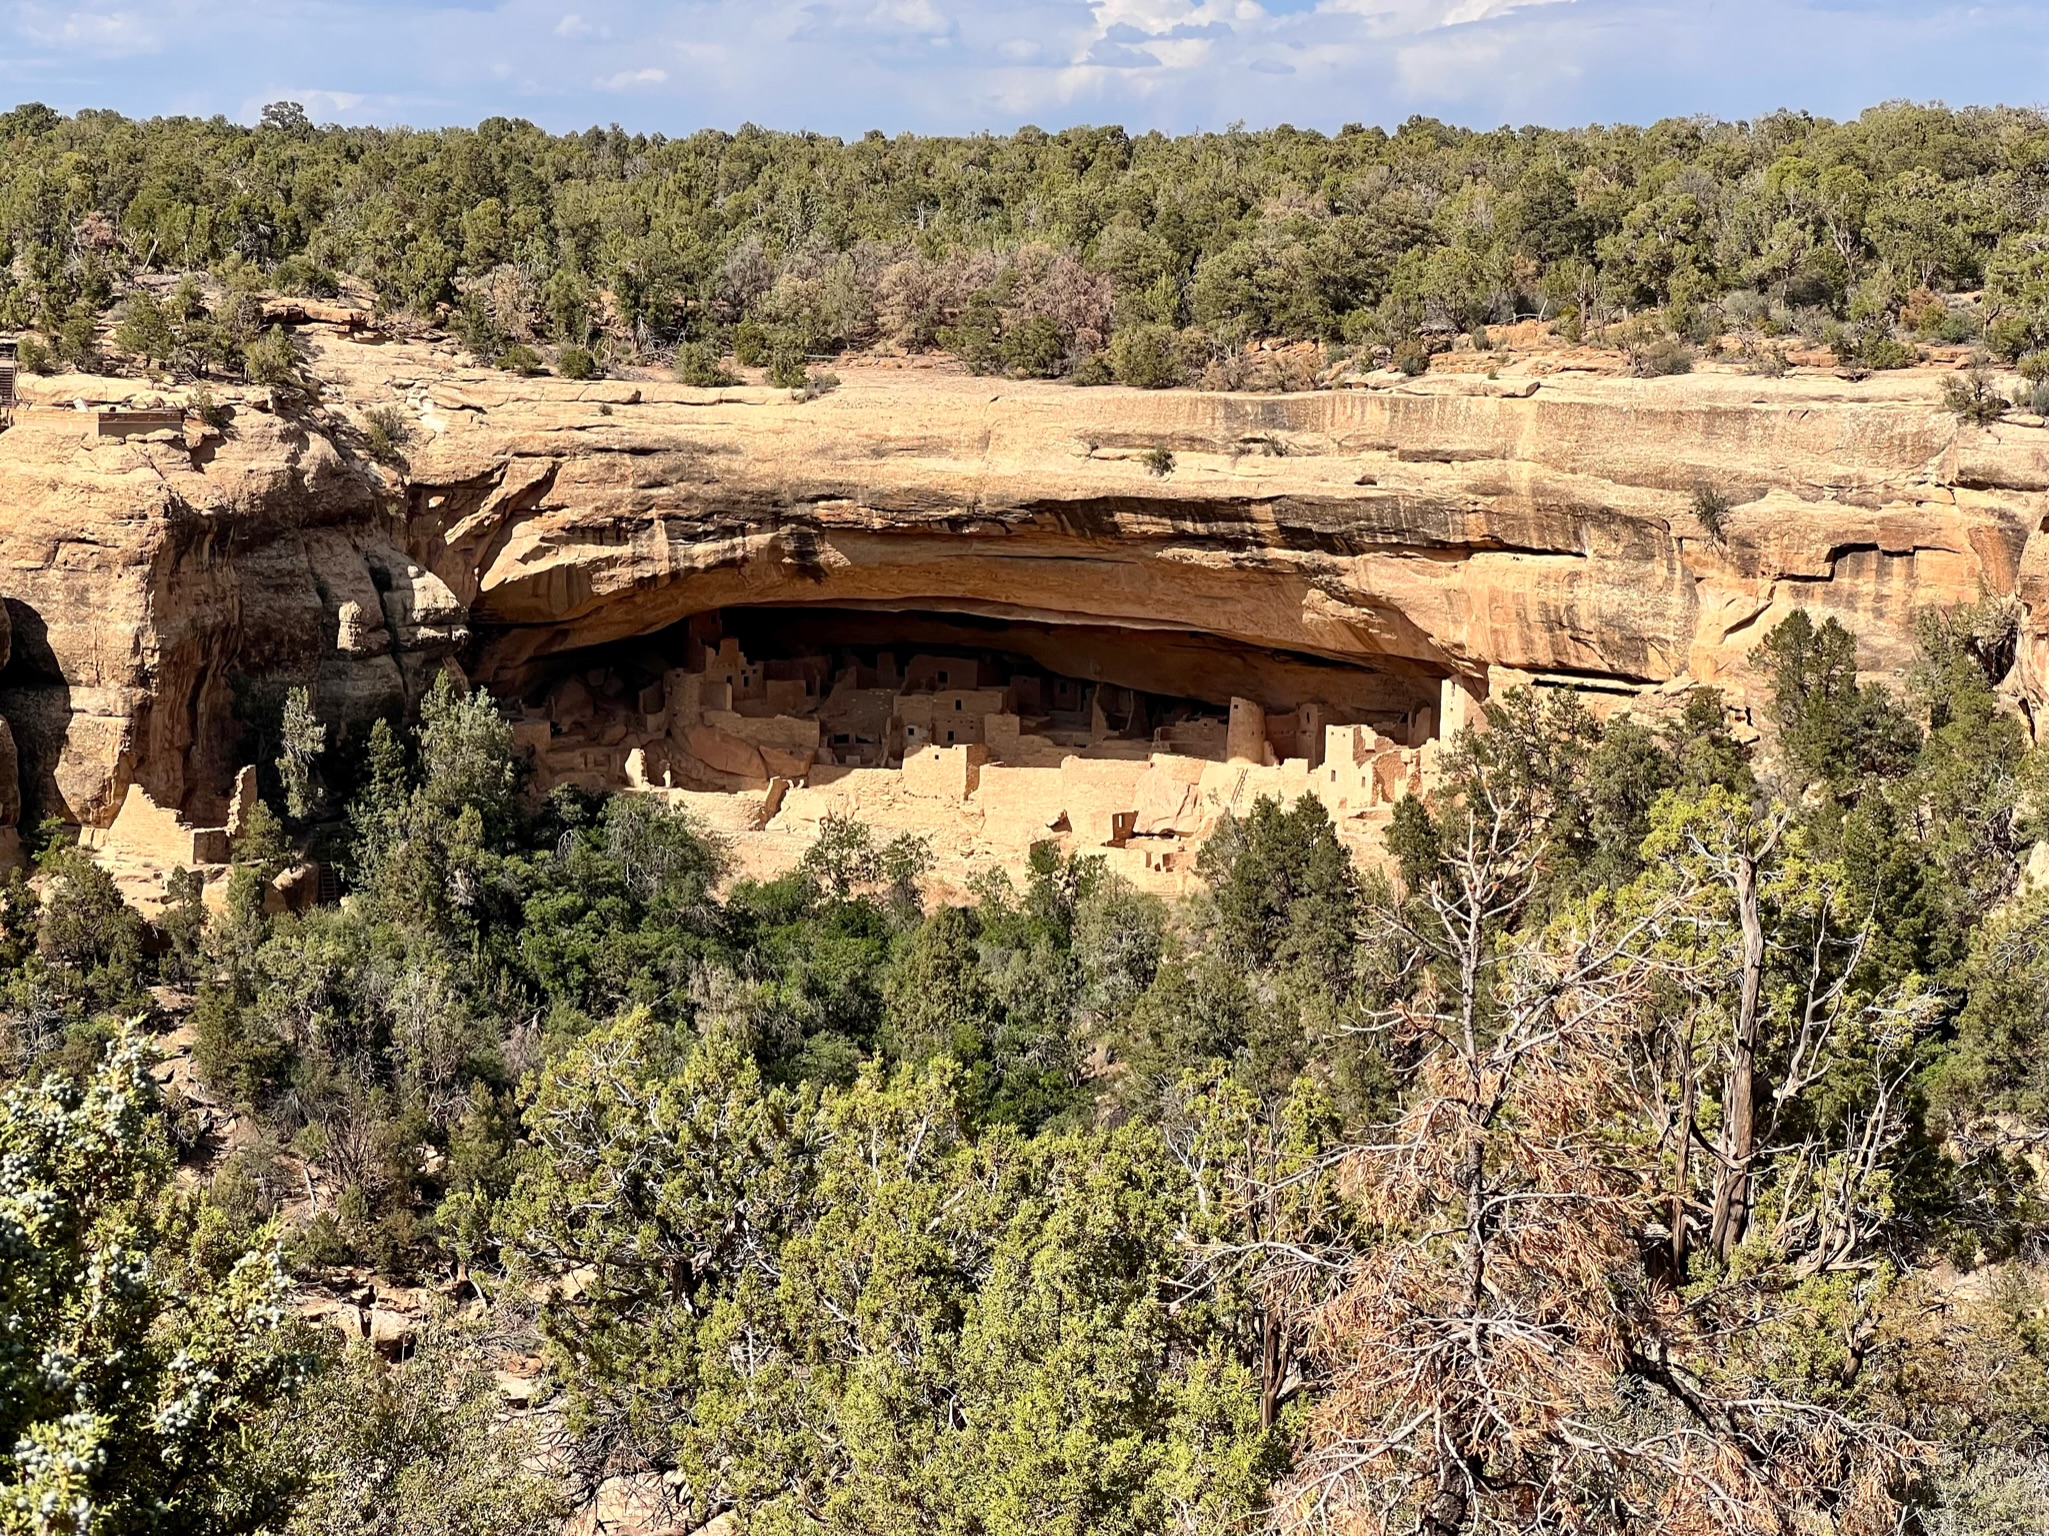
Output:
[{"xmin": 0, "ymin": 1032, "xmax": 307, "ymax": 1536}]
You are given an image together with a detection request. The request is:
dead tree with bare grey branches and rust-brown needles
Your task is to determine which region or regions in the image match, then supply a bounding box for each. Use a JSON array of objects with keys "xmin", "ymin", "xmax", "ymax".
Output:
[{"xmin": 1274, "ymin": 776, "xmax": 1912, "ymax": 1536}]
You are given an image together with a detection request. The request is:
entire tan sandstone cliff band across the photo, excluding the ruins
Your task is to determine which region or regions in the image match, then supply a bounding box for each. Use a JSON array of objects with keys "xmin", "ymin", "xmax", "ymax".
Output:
[{"xmin": 0, "ymin": 342, "xmax": 2049, "ymax": 823}]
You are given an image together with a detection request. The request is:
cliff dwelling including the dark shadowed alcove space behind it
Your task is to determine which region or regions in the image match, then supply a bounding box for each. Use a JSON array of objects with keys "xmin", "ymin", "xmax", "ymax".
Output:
[{"xmin": 514, "ymin": 606, "xmax": 1471, "ymax": 889}]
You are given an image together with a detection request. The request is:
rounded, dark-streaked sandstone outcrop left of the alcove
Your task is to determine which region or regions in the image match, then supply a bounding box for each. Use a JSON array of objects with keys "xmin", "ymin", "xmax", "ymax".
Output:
[{"xmin": 0, "ymin": 381, "xmax": 463, "ymax": 823}]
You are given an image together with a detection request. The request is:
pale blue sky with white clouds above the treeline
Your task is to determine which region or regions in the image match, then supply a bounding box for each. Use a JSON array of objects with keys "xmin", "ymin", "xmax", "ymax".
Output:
[{"xmin": 0, "ymin": 0, "xmax": 2049, "ymax": 135}]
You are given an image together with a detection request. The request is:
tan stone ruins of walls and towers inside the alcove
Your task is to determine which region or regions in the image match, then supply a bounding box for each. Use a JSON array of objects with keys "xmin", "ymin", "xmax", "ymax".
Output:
[{"xmin": 512, "ymin": 614, "xmax": 1475, "ymax": 893}]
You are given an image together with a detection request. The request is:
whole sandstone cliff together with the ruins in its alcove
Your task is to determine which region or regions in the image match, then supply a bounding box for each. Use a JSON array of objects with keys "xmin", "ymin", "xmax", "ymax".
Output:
[{"xmin": 0, "ymin": 338, "xmax": 2049, "ymax": 897}]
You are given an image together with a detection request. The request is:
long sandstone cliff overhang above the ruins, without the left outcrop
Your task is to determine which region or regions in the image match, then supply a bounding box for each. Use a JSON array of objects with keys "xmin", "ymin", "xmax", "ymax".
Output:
[{"xmin": 391, "ymin": 364, "xmax": 2045, "ymax": 724}]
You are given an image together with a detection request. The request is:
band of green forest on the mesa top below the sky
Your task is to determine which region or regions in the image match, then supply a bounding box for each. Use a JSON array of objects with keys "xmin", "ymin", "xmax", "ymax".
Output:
[{"xmin": 0, "ymin": 102, "xmax": 2049, "ymax": 383}]
